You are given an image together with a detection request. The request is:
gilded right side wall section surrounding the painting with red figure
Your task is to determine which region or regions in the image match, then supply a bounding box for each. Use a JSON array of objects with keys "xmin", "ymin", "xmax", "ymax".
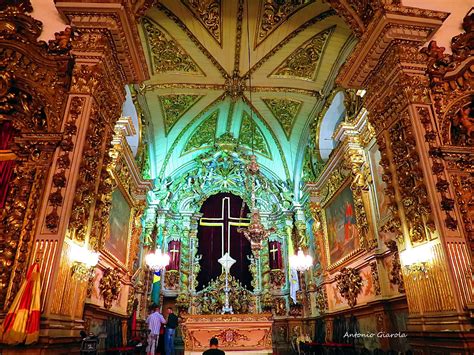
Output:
[{"xmin": 306, "ymin": 94, "xmax": 406, "ymax": 348}]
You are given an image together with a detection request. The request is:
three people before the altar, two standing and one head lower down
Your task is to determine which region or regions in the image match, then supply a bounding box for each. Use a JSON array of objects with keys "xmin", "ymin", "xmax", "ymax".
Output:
[{"xmin": 146, "ymin": 306, "xmax": 225, "ymax": 355}]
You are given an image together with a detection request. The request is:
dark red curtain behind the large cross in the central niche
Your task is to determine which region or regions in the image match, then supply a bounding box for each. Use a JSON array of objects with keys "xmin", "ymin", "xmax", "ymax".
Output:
[{"xmin": 197, "ymin": 193, "xmax": 252, "ymax": 290}]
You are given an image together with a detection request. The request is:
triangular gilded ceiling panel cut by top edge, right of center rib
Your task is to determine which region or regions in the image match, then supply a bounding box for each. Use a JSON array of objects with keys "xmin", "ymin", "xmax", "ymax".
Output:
[{"xmin": 255, "ymin": 0, "xmax": 315, "ymax": 47}]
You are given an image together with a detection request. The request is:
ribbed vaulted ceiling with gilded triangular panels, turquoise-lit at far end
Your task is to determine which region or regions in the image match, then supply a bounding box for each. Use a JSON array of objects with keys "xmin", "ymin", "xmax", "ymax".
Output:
[{"xmin": 136, "ymin": 0, "xmax": 354, "ymax": 193}]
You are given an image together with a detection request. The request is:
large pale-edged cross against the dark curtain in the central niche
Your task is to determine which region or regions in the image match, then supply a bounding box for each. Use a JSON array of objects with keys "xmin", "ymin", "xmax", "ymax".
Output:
[{"xmin": 199, "ymin": 197, "xmax": 250, "ymax": 270}]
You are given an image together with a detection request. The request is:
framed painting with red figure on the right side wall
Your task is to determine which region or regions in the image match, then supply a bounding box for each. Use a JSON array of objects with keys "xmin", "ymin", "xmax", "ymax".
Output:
[{"xmin": 324, "ymin": 184, "xmax": 359, "ymax": 264}]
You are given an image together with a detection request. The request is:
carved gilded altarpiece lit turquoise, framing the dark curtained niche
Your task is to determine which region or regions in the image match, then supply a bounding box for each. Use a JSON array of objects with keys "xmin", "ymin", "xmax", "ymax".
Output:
[{"xmin": 143, "ymin": 135, "xmax": 302, "ymax": 317}]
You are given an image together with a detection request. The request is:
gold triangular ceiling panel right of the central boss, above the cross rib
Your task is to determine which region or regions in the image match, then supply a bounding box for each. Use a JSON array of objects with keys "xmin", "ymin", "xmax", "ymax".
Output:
[{"xmin": 270, "ymin": 28, "xmax": 333, "ymax": 81}]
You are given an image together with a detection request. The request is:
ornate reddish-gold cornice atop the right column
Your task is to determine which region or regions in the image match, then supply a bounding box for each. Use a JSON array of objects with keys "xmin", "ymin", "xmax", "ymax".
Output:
[{"xmin": 337, "ymin": 6, "xmax": 448, "ymax": 89}]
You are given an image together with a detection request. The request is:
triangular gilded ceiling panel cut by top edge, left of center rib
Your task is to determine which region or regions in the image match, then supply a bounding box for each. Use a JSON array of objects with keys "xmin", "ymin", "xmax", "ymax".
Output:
[{"xmin": 181, "ymin": 0, "xmax": 222, "ymax": 45}]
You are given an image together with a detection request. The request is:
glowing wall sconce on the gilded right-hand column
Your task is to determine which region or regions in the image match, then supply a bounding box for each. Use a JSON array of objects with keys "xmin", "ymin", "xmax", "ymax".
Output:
[{"xmin": 400, "ymin": 243, "xmax": 433, "ymax": 280}]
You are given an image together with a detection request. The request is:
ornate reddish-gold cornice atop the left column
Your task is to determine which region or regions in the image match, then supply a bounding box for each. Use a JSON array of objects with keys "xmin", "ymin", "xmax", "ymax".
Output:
[{"xmin": 55, "ymin": 0, "xmax": 149, "ymax": 83}]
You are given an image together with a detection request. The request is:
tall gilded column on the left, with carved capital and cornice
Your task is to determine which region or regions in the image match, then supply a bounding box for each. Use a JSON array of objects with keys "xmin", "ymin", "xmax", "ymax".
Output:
[{"xmin": 27, "ymin": 1, "xmax": 147, "ymax": 337}]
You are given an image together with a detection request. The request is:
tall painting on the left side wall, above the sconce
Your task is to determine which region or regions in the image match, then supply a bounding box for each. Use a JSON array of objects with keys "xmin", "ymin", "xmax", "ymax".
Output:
[{"xmin": 105, "ymin": 189, "xmax": 132, "ymax": 264}]
